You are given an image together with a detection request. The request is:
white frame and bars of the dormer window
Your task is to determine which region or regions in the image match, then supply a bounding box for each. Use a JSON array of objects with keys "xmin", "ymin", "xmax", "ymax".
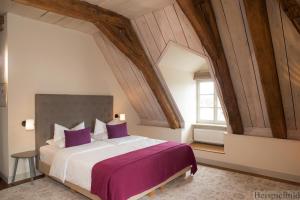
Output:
[{"xmin": 196, "ymin": 78, "xmax": 226, "ymax": 125}]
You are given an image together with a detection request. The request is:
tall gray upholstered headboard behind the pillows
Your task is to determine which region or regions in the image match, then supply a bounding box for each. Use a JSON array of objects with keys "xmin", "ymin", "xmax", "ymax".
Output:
[{"xmin": 35, "ymin": 94, "xmax": 113, "ymax": 152}]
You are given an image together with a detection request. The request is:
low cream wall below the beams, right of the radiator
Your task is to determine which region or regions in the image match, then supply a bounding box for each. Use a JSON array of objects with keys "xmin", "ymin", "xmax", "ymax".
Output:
[{"xmin": 194, "ymin": 134, "xmax": 300, "ymax": 182}]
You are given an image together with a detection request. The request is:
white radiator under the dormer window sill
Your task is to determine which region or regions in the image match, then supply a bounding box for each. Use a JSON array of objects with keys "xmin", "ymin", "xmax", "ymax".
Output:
[{"xmin": 194, "ymin": 128, "xmax": 225, "ymax": 145}]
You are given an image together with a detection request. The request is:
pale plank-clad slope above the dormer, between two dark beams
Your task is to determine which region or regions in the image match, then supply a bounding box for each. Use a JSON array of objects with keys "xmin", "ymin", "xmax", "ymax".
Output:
[{"xmin": 131, "ymin": 4, "xmax": 231, "ymax": 130}]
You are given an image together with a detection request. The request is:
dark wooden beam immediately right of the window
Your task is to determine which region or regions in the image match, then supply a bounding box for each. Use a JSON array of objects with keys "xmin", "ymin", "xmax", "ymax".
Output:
[{"xmin": 177, "ymin": 0, "xmax": 244, "ymax": 134}]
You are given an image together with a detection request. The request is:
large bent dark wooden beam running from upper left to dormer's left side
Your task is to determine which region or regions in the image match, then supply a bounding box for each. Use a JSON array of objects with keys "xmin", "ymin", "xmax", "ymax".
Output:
[{"xmin": 14, "ymin": 0, "xmax": 181, "ymax": 129}]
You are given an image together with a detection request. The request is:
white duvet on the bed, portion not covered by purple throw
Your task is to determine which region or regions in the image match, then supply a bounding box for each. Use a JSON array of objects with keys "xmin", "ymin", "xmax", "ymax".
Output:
[{"xmin": 50, "ymin": 136, "xmax": 164, "ymax": 191}]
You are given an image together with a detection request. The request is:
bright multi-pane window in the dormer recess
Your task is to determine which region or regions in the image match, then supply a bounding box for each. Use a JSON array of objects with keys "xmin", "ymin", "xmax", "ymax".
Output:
[{"xmin": 197, "ymin": 80, "xmax": 225, "ymax": 124}]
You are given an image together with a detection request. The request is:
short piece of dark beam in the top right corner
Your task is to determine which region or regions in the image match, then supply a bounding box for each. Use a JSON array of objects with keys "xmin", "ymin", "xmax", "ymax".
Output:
[{"xmin": 280, "ymin": 0, "xmax": 300, "ymax": 34}]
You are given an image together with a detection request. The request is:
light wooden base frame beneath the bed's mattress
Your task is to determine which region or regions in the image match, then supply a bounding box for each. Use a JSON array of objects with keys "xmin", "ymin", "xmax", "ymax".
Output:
[{"xmin": 38, "ymin": 161, "xmax": 192, "ymax": 200}]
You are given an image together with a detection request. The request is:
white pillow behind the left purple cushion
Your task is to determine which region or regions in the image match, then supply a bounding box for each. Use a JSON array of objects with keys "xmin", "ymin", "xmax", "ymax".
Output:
[{"xmin": 53, "ymin": 122, "xmax": 85, "ymax": 148}]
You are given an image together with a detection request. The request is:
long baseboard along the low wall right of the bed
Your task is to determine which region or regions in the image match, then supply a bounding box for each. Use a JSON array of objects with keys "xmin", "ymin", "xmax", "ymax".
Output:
[{"xmin": 197, "ymin": 158, "xmax": 300, "ymax": 183}]
